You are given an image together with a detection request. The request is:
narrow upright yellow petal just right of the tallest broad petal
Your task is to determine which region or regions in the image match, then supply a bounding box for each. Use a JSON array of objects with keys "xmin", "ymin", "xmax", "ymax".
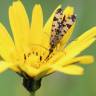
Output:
[{"xmin": 30, "ymin": 4, "xmax": 43, "ymax": 45}]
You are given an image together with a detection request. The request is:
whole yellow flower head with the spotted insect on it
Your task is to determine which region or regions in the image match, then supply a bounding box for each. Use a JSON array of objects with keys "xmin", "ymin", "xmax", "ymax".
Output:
[{"xmin": 0, "ymin": 0, "xmax": 96, "ymax": 90}]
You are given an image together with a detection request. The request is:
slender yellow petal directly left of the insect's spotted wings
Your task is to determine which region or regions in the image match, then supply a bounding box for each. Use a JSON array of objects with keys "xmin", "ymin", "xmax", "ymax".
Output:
[{"xmin": 42, "ymin": 5, "xmax": 61, "ymax": 48}]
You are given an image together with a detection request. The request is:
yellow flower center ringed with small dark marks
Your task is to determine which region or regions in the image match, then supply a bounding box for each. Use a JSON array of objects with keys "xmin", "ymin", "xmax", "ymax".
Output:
[{"xmin": 24, "ymin": 46, "xmax": 49, "ymax": 69}]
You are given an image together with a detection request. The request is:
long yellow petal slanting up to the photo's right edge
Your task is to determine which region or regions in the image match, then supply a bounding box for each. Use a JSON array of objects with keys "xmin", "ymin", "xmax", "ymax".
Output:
[{"xmin": 52, "ymin": 27, "xmax": 96, "ymax": 66}]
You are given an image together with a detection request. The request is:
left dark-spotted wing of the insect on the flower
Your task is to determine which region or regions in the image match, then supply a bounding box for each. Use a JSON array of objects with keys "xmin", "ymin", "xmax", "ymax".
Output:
[{"xmin": 50, "ymin": 8, "xmax": 63, "ymax": 49}]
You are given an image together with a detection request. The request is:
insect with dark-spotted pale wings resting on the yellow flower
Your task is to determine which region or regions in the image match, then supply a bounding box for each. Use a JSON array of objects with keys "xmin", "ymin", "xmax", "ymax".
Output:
[{"xmin": 49, "ymin": 8, "xmax": 76, "ymax": 53}]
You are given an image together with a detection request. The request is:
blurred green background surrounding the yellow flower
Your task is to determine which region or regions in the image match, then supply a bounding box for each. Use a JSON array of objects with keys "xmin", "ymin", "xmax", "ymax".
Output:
[{"xmin": 0, "ymin": 0, "xmax": 96, "ymax": 96}]
